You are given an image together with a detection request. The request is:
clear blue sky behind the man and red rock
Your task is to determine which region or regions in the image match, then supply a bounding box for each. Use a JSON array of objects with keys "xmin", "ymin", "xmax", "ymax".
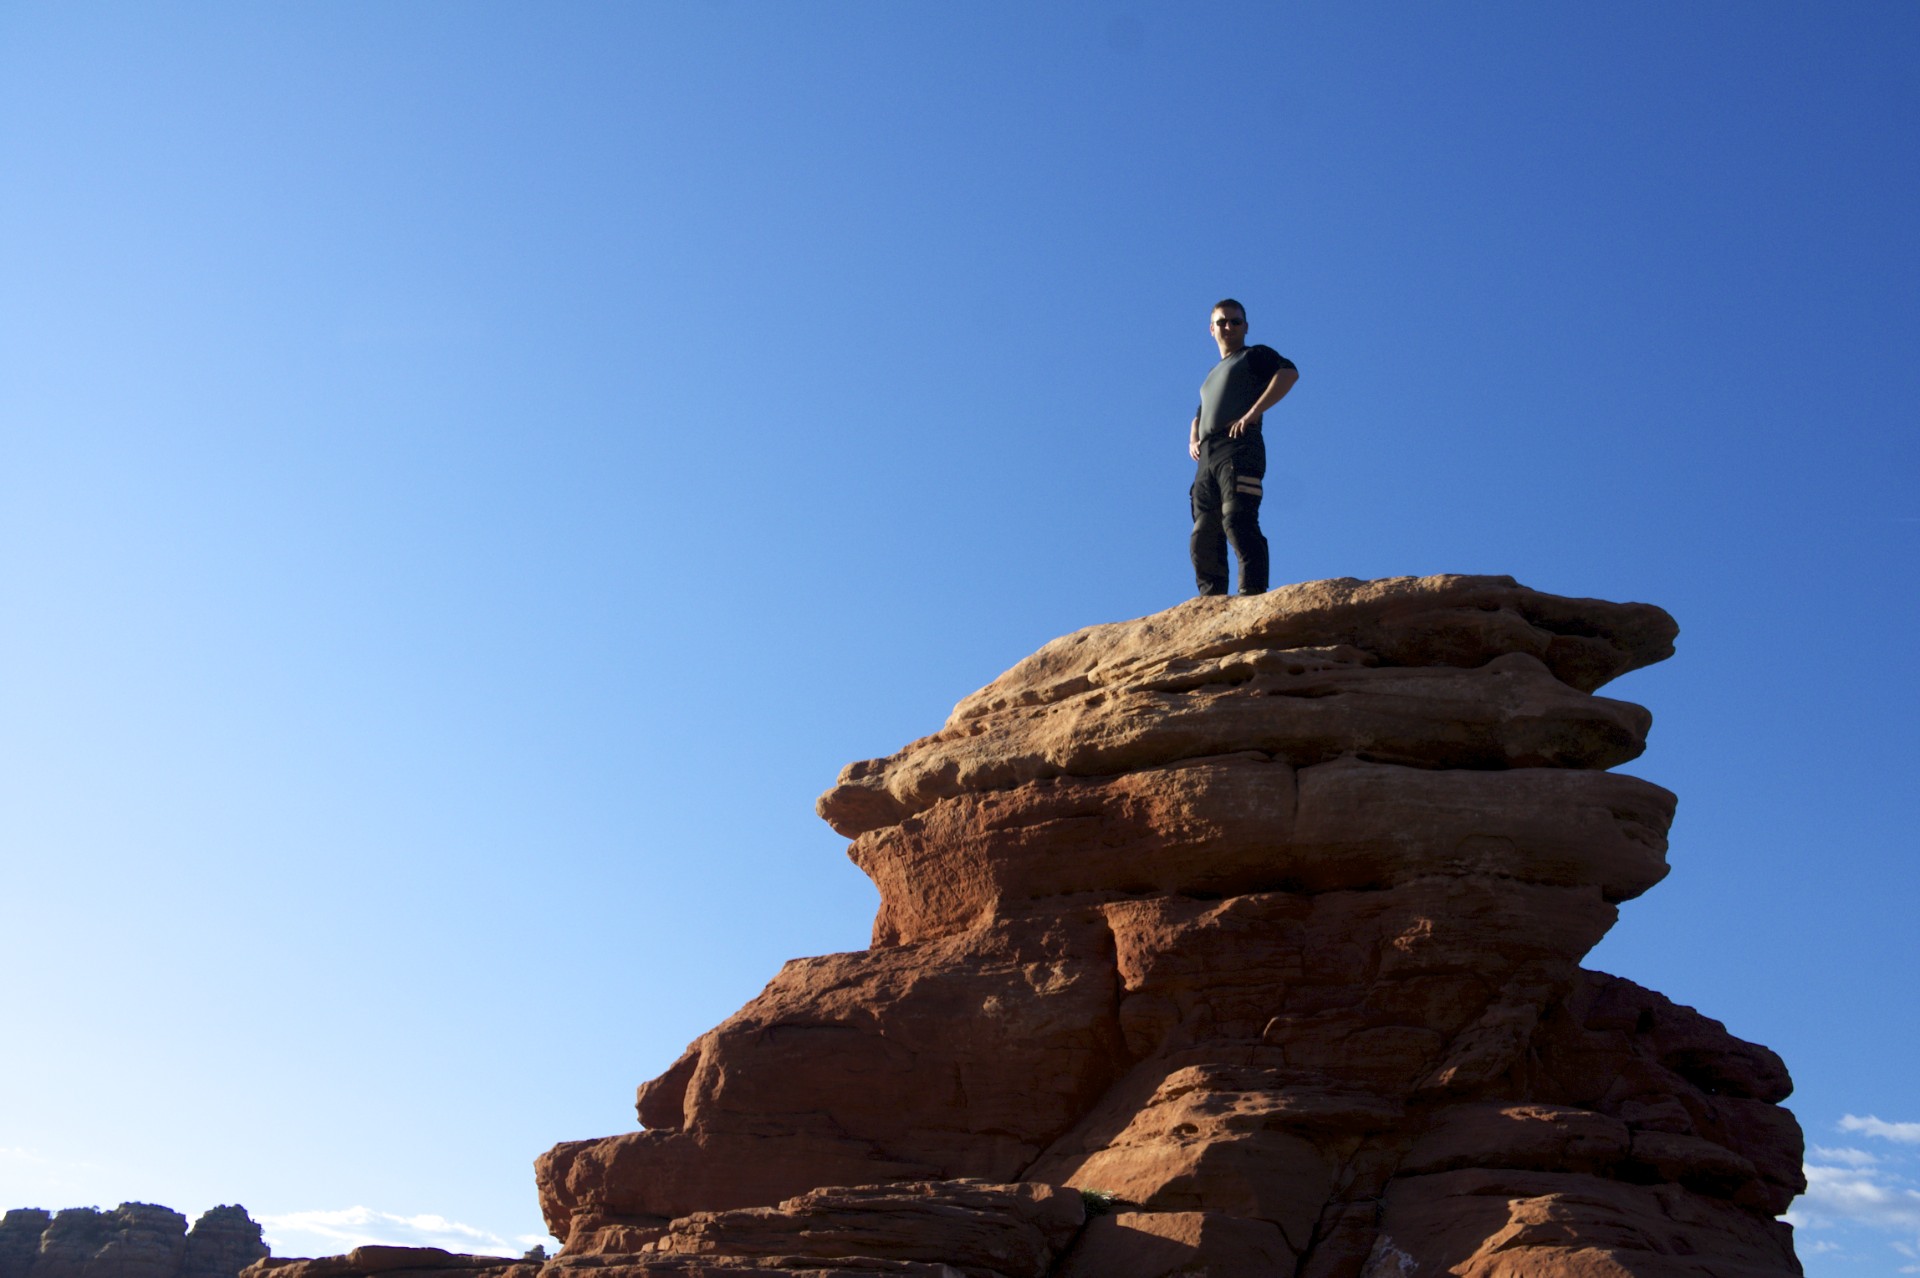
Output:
[{"xmin": 0, "ymin": 0, "xmax": 1920, "ymax": 1278}]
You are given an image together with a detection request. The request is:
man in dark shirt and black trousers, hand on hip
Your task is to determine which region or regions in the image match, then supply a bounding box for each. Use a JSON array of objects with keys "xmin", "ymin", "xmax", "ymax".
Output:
[{"xmin": 1187, "ymin": 297, "xmax": 1300, "ymax": 595}]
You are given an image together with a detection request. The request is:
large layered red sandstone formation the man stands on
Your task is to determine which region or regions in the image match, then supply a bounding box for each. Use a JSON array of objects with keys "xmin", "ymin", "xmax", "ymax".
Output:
[{"xmin": 274, "ymin": 576, "xmax": 1805, "ymax": 1278}]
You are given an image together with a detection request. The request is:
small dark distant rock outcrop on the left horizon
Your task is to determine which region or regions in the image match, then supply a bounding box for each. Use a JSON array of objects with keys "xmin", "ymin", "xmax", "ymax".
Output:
[{"xmin": 0, "ymin": 1203, "xmax": 267, "ymax": 1278}]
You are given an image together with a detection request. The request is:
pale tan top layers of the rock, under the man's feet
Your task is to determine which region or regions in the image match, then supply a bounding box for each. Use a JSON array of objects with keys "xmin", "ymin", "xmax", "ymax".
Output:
[{"xmin": 818, "ymin": 576, "xmax": 1678, "ymax": 837}]
